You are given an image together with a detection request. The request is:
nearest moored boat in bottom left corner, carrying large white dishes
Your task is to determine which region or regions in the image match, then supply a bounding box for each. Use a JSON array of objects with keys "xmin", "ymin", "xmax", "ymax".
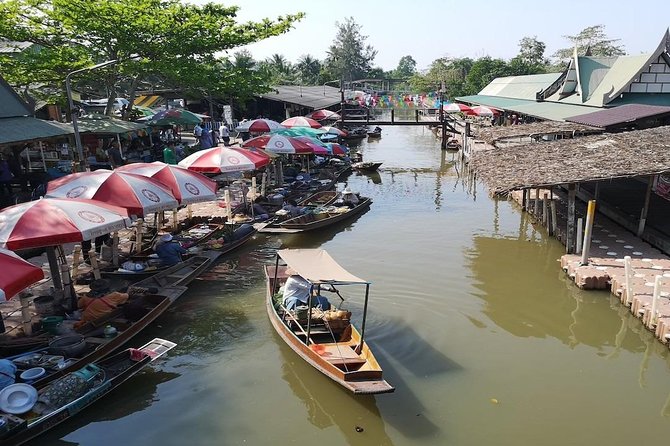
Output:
[{"xmin": 0, "ymin": 338, "xmax": 177, "ymax": 446}]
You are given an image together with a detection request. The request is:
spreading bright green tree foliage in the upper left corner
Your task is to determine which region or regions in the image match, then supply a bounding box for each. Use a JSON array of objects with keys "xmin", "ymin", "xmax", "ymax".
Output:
[{"xmin": 0, "ymin": 0, "xmax": 302, "ymax": 115}]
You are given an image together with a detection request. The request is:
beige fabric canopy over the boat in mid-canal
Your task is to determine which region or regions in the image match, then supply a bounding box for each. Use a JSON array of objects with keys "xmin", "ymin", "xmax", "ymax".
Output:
[{"xmin": 277, "ymin": 249, "xmax": 370, "ymax": 285}]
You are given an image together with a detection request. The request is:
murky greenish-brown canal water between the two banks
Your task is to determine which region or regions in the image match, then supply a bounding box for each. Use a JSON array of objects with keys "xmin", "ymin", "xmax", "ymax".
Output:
[{"xmin": 35, "ymin": 123, "xmax": 670, "ymax": 446}]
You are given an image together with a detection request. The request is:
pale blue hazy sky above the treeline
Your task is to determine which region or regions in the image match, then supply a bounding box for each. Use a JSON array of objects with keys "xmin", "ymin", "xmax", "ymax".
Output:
[{"xmin": 213, "ymin": 0, "xmax": 670, "ymax": 70}]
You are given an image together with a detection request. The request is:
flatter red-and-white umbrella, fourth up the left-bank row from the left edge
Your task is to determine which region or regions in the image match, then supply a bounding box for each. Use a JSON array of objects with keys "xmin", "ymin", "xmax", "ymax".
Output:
[{"xmin": 179, "ymin": 146, "xmax": 270, "ymax": 173}]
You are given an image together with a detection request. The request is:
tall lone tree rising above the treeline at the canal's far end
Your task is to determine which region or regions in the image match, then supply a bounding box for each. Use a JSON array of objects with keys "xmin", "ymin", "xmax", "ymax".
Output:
[{"xmin": 324, "ymin": 17, "xmax": 377, "ymax": 81}]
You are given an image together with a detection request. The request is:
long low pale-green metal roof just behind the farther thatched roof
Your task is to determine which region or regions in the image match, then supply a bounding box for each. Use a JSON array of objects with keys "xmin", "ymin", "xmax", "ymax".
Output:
[{"xmin": 456, "ymin": 95, "xmax": 596, "ymax": 121}]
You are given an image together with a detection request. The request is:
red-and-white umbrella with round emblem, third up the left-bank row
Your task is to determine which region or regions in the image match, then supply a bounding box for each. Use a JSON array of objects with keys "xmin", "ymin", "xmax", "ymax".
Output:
[{"xmin": 116, "ymin": 161, "xmax": 216, "ymax": 204}]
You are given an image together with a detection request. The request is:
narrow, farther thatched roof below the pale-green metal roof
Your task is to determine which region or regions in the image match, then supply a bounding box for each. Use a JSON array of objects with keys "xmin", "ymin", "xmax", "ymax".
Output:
[{"xmin": 473, "ymin": 121, "xmax": 603, "ymax": 144}]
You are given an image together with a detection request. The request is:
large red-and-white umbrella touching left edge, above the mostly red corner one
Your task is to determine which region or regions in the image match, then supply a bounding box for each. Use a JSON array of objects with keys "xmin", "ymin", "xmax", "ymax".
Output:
[{"xmin": 0, "ymin": 198, "xmax": 131, "ymax": 250}]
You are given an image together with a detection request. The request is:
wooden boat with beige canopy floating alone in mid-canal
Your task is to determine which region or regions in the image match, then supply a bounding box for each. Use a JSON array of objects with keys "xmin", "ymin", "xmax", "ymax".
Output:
[{"xmin": 265, "ymin": 249, "xmax": 395, "ymax": 394}]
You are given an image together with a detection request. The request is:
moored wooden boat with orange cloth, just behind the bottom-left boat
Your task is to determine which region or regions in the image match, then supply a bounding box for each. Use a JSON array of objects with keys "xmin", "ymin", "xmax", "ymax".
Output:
[{"xmin": 6, "ymin": 253, "xmax": 221, "ymax": 388}]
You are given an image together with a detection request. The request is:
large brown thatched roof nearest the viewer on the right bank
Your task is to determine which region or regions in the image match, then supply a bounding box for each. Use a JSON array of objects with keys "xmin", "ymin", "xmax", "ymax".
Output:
[{"xmin": 470, "ymin": 126, "xmax": 670, "ymax": 194}]
